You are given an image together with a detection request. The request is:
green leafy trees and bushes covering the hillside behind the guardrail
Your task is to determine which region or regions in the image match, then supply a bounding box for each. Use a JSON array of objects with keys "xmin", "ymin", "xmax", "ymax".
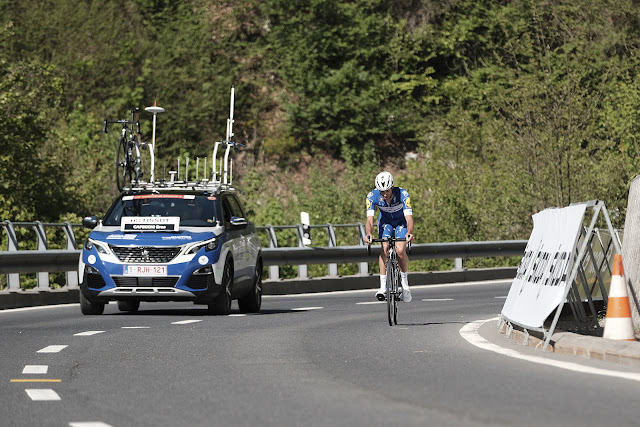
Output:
[{"xmin": 0, "ymin": 0, "xmax": 640, "ymax": 270}]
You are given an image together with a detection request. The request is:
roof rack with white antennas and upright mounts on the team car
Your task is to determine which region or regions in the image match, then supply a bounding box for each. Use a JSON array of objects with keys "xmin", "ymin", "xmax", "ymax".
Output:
[{"xmin": 123, "ymin": 86, "xmax": 244, "ymax": 192}]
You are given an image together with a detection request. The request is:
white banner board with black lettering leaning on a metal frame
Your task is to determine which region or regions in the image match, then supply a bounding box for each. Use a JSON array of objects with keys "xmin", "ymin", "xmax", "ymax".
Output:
[{"xmin": 502, "ymin": 203, "xmax": 587, "ymax": 328}]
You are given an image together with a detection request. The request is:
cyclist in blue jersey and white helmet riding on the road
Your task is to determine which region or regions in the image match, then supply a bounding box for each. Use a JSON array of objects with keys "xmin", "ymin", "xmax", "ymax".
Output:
[{"xmin": 365, "ymin": 171, "xmax": 414, "ymax": 302}]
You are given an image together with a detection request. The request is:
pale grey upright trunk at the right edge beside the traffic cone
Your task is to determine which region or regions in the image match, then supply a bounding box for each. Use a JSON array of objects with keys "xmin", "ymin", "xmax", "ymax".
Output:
[{"xmin": 622, "ymin": 175, "xmax": 640, "ymax": 337}]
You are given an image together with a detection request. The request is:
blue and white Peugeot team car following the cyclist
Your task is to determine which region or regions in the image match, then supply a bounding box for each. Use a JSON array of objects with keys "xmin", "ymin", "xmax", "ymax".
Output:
[{"xmin": 79, "ymin": 187, "xmax": 263, "ymax": 315}]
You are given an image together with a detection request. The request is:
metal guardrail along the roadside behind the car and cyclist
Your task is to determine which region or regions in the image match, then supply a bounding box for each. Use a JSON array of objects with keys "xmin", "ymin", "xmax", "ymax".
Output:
[{"xmin": 0, "ymin": 221, "xmax": 527, "ymax": 292}]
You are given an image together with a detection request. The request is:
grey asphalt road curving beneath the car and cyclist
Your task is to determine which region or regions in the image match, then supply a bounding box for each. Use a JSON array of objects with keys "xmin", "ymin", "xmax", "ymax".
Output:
[{"xmin": 0, "ymin": 281, "xmax": 640, "ymax": 427}]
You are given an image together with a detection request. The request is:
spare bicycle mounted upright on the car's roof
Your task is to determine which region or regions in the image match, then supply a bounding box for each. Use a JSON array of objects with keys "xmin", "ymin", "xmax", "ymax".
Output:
[{"xmin": 103, "ymin": 107, "xmax": 147, "ymax": 191}]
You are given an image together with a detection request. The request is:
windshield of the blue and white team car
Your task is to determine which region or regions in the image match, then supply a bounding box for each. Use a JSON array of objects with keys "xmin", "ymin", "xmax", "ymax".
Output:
[{"xmin": 103, "ymin": 194, "xmax": 218, "ymax": 227}]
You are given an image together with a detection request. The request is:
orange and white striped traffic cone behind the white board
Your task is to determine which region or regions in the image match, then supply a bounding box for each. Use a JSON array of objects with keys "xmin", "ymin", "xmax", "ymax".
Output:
[{"xmin": 602, "ymin": 255, "xmax": 636, "ymax": 341}]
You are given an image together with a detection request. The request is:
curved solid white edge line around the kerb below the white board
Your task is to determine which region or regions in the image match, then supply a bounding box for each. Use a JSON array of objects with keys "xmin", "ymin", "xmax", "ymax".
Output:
[{"xmin": 459, "ymin": 317, "xmax": 640, "ymax": 381}]
